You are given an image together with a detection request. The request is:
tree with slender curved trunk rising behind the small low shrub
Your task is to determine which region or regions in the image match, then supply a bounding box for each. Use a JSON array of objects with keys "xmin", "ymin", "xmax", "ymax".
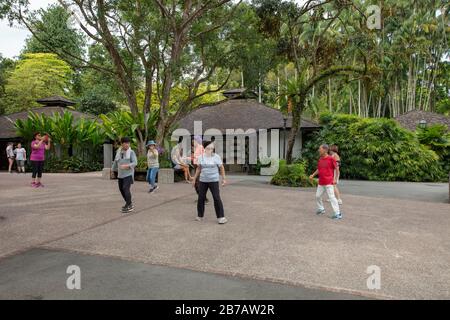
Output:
[{"xmin": 253, "ymin": 0, "xmax": 365, "ymax": 163}]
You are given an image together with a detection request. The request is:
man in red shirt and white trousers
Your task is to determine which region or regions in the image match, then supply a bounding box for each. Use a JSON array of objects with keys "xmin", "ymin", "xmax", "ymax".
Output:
[{"xmin": 309, "ymin": 144, "xmax": 342, "ymax": 219}]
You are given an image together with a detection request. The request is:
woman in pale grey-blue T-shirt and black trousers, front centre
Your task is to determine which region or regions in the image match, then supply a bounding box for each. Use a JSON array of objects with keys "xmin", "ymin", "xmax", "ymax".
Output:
[{"xmin": 194, "ymin": 142, "xmax": 227, "ymax": 224}]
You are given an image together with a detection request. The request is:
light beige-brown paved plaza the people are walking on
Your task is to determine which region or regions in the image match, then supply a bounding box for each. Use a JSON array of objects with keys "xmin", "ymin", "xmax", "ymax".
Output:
[{"xmin": 0, "ymin": 173, "xmax": 450, "ymax": 299}]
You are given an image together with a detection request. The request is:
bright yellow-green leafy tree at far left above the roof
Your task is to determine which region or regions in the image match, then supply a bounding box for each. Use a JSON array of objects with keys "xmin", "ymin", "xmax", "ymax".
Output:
[{"xmin": 4, "ymin": 53, "xmax": 73, "ymax": 113}]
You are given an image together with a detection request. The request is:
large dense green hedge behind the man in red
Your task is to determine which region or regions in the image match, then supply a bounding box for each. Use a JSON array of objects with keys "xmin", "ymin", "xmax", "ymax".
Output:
[{"xmin": 302, "ymin": 113, "xmax": 448, "ymax": 181}]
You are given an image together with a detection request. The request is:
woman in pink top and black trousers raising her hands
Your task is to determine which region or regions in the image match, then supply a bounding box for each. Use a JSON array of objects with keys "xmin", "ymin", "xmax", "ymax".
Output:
[{"xmin": 30, "ymin": 132, "xmax": 51, "ymax": 188}]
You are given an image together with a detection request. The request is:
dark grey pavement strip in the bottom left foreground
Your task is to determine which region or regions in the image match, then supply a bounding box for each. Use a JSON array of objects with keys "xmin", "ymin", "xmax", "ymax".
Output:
[{"xmin": 0, "ymin": 249, "xmax": 363, "ymax": 300}]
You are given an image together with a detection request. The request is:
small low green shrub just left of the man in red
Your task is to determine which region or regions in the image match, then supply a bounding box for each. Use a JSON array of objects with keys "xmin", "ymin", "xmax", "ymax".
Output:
[{"xmin": 270, "ymin": 160, "xmax": 317, "ymax": 187}]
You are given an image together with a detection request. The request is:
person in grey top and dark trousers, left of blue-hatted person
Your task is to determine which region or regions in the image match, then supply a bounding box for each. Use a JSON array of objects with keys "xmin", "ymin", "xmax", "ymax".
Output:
[{"xmin": 112, "ymin": 137, "xmax": 137, "ymax": 213}]
